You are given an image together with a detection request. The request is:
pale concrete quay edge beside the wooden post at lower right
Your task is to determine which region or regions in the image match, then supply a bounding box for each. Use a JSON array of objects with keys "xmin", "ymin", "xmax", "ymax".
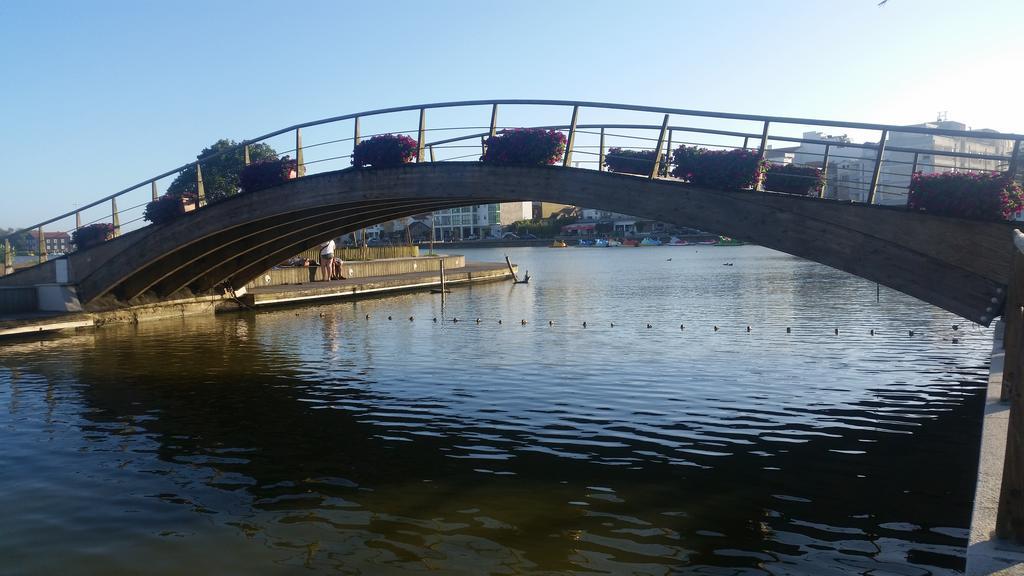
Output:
[{"xmin": 967, "ymin": 321, "xmax": 1024, "ymax": 576}]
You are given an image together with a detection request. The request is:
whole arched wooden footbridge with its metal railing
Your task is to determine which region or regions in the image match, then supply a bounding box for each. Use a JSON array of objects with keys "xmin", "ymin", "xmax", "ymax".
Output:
[{"xmin": 0, "ymin": 100, "xmax": 1024, "ymax": 325}]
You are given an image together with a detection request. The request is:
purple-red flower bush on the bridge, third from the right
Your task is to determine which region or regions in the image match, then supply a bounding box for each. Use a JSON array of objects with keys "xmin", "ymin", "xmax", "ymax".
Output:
[{"xmin": 672, "ymin": 145, "xmax": 765, "ymax": 190}]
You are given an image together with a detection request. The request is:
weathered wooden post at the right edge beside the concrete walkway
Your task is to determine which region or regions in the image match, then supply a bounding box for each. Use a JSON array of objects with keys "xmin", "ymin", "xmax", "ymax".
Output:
[{"xmin": 995, "ymin": 231, "xmax": 1024, "ymax": 544}]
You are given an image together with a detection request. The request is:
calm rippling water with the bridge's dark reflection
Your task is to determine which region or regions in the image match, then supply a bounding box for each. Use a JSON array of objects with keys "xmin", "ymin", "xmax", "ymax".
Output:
[{"xmin": 0, "ymin": 247, "xmax": 991, "ymax": 575}]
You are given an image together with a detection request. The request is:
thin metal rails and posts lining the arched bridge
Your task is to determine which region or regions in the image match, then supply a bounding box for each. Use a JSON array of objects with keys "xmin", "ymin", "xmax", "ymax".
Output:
[{"xmin": 0, "ymin": 99, "xmax": 1024, "ymax": 258}]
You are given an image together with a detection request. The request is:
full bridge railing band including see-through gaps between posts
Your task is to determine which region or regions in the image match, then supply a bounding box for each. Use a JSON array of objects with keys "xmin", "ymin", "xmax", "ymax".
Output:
[{"xmin": 0, "ymin": 99, "xmax": 1024, "ymax": 261}]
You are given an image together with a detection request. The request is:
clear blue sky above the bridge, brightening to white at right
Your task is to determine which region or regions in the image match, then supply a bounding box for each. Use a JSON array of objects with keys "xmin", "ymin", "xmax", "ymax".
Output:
[{"xmin": 0, "ymin": 0, "xmax": 1024, "ymax": 227}]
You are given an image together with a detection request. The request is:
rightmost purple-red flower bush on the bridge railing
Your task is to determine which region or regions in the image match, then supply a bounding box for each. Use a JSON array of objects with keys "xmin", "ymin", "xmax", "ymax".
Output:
[{"xmin": 907, "ymin": 172, "xmax": 1024, "ymax": 220}]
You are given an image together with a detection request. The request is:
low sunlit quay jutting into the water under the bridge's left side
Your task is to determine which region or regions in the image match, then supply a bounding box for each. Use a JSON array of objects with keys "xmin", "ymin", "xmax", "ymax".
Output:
[{"xmin": 0, "ymin": 256, "xmax": 515, "ymax": 338}]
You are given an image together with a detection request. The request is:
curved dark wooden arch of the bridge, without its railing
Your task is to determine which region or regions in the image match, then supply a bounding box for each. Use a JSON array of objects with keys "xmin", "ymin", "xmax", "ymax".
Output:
[{"xmin": 71, "ymin": 163, "xmax": 1013, "ymax": 325}]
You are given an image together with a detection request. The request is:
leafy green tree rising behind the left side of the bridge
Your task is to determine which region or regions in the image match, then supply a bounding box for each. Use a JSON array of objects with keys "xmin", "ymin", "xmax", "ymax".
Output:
[{"xmin": 167, "ymin": 138, "xmax": 278, "ymax": 202}]
